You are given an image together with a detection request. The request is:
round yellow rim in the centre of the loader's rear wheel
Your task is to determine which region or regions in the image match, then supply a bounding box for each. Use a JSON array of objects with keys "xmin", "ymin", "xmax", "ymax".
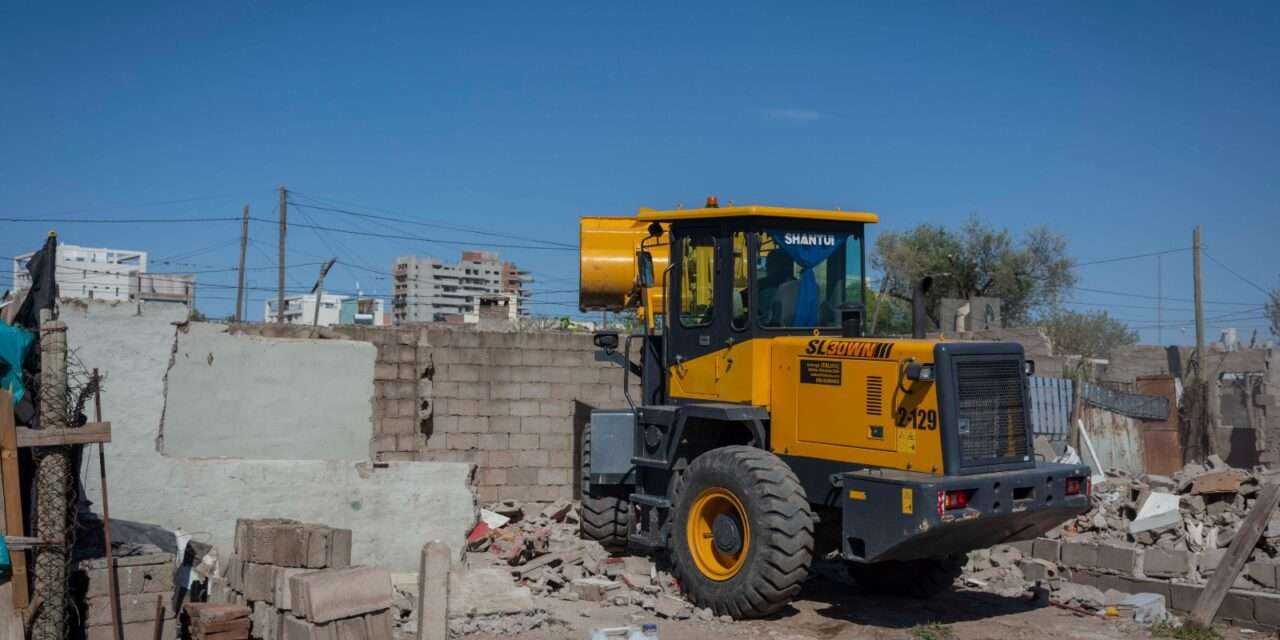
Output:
[{"xmin": 685, "ymin": 486, "xmax": 751, "ymax": 582}]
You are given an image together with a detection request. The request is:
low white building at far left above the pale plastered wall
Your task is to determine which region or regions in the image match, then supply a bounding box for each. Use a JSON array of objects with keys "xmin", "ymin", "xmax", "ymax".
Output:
[{"xmin": 13, "ymin": 244, "xmax": 196, "ymax": 303}]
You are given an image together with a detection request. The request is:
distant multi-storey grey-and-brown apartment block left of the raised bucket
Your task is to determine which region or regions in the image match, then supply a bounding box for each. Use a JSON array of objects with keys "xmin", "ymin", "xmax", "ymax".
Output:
[{"xmin": 392, "ymin": 251, "xmax": 532, "ymax": 324}]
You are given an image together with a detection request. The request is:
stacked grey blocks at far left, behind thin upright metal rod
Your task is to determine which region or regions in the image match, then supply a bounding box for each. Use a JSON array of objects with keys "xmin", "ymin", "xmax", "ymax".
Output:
[{"xmin": 72, "ymin": 545, "xmax": 178, "ymax": 640}]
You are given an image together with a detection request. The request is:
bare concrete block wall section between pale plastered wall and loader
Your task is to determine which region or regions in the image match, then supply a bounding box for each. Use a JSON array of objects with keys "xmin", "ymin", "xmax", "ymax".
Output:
[{"xmin": 419, "ymin": 328, "xmax": 626, "ymax": 503}]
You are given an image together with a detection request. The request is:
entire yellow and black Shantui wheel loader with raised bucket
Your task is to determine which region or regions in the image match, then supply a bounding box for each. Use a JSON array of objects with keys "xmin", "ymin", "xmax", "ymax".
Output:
[{"xmin": 580, "ymin": 200, "xmax": 1091, "ymax": 618}]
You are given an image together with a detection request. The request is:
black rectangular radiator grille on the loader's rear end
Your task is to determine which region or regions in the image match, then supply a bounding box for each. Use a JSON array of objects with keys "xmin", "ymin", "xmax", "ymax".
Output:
[{"xmin": 956, "ymin": 360, "xmax": 1029, "ymax": 467}]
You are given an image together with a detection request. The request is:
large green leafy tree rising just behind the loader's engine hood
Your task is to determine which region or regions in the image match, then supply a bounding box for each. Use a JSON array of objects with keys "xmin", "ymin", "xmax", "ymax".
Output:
[{"xmin": 872, "ymin": 215, "xmax": 1075, "ymax": 325}]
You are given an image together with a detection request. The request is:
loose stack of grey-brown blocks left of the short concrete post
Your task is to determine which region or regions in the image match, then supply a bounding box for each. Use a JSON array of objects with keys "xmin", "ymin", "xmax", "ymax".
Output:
[{"xmin": 209, "ymin": 518, "xmax": 392, "ymax": 640}]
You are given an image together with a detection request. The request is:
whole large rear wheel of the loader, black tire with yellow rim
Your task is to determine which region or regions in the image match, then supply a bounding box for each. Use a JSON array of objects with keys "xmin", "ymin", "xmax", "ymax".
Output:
[{"xmin": 669, "ymin": 447, "xmax": 813, "ymax": 618}]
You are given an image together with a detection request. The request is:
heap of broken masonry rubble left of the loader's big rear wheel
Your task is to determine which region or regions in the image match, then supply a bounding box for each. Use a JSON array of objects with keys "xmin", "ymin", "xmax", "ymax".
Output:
[{"xmin": 463, "ymin": 499, "xmax": 709, "ymax": 620}]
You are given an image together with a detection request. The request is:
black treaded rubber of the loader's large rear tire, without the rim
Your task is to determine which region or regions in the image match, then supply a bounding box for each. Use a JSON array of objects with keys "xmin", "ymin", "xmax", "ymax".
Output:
[{"xmin": 668, "ymin": 445, "xmax": 813, "ymax": 620}]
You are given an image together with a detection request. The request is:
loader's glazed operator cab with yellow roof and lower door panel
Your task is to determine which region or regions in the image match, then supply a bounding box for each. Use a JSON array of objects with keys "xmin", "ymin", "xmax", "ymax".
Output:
[{"xmin": 641, "ymin": 207, "xmax": 876, "ymax": 404}]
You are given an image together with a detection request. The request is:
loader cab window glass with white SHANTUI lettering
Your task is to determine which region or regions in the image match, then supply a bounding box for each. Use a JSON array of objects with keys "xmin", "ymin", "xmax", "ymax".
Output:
[{"xmin": 755, "ymin": 228, "xmax": 863, "ymax": 328}]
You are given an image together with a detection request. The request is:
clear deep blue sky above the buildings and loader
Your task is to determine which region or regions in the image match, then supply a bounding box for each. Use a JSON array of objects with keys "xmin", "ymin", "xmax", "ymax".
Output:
[{"xmin": 0, "ymin": 3, "xmax": 1280, "ymax": 342}]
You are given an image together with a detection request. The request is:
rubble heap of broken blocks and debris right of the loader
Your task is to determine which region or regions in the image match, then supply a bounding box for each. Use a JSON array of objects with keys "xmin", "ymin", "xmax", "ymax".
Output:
[{"xmin": 959, "ymin": 456, "xmax": 1280, "ymax": 626}]
